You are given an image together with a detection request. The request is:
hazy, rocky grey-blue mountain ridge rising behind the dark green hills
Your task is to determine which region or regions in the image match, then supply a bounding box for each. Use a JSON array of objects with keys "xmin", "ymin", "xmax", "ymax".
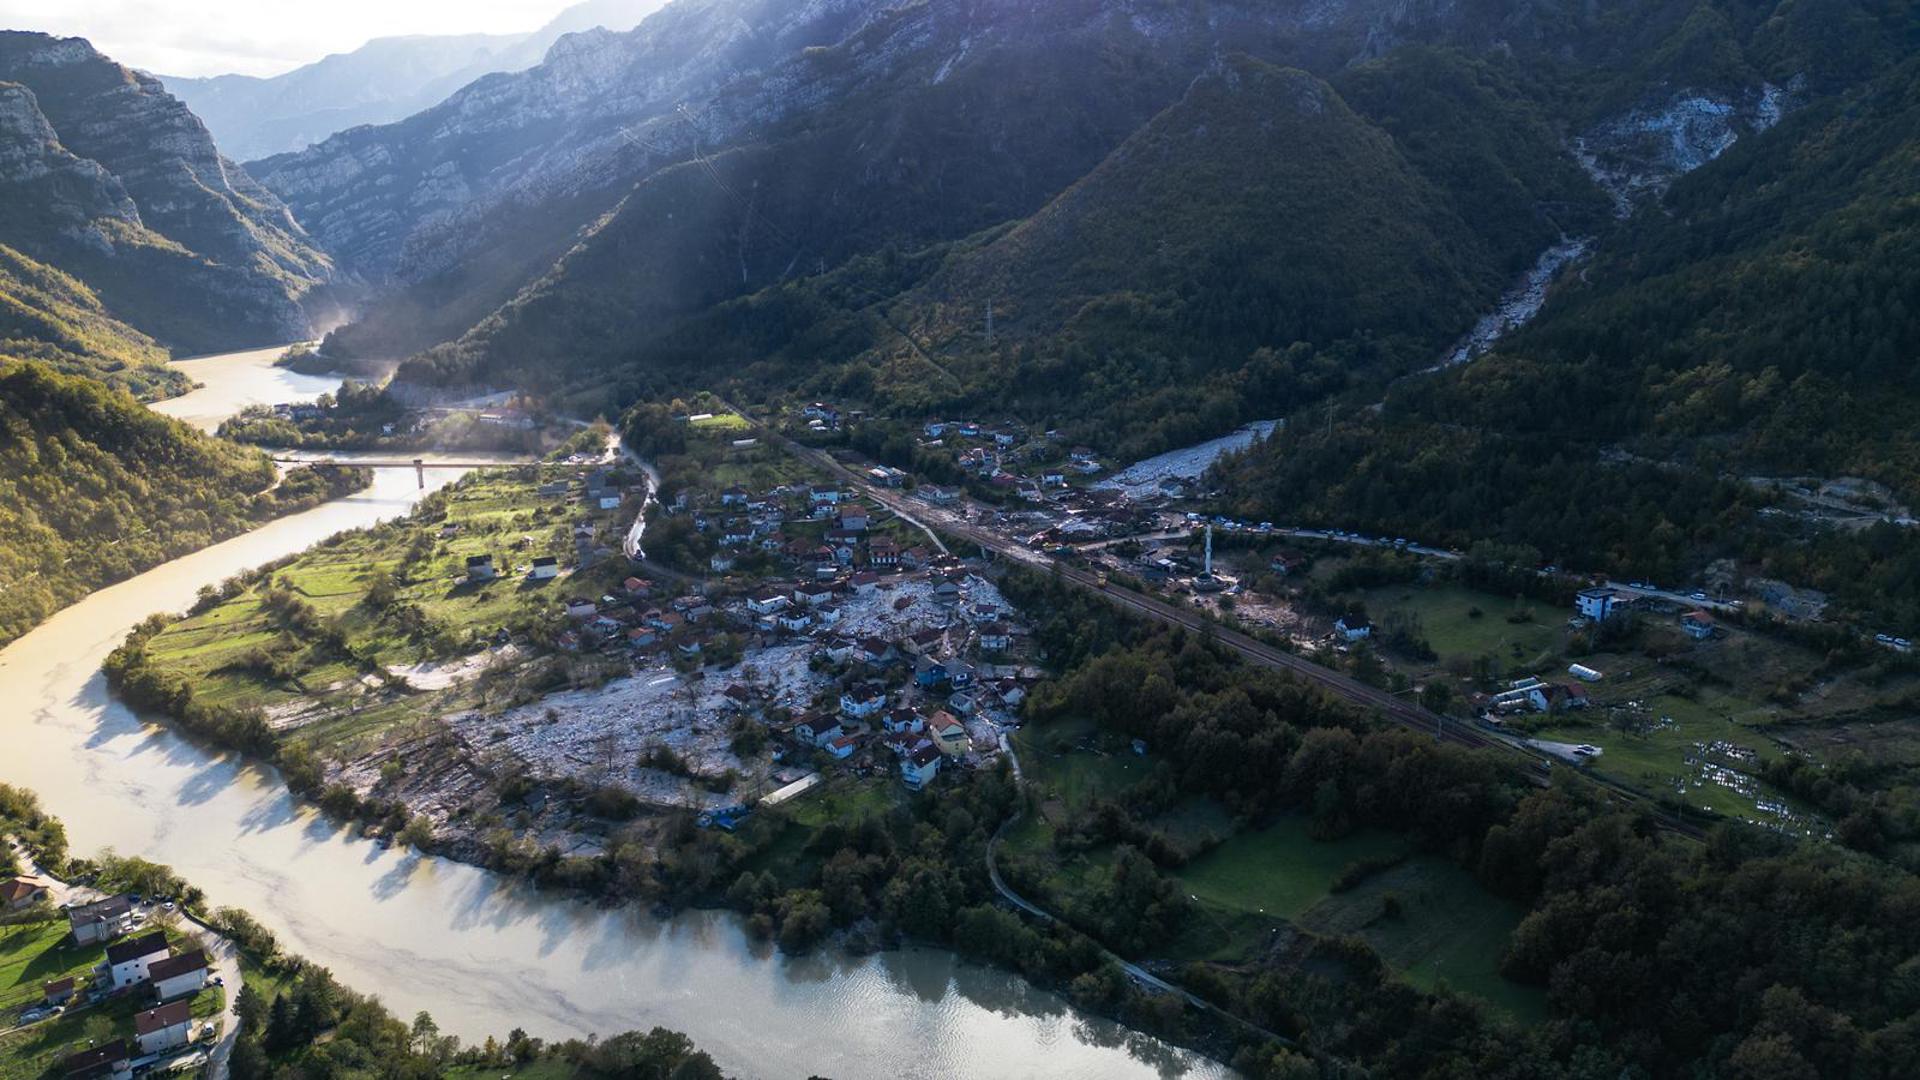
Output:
[{"xmin": 291, "ymin": 0, "xmax": 1745, "ymax": 377}]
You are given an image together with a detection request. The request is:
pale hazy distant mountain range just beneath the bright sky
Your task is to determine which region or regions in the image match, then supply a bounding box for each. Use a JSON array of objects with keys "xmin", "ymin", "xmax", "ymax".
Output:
[{"xmin": 159, "ymin": 0, "xmax": 666, "ymax": 161}]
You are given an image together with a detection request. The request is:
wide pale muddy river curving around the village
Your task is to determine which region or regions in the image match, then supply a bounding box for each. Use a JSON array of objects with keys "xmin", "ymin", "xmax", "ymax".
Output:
[{"xmin": 0, "ymin": 350, "xmax": 1229, "ymax": 1080}]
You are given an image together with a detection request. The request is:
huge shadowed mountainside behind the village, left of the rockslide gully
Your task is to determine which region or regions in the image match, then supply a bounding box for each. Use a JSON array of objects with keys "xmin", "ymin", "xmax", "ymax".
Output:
[{"xmin": 330, "ymin": 0, "xmax": 1893, "ymax": 454}]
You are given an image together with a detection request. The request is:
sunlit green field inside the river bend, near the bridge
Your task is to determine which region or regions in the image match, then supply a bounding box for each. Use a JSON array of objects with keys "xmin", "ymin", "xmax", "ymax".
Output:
[{"xmin": 148, "ymin": 457, "xmax": 630, "ymax": 746}]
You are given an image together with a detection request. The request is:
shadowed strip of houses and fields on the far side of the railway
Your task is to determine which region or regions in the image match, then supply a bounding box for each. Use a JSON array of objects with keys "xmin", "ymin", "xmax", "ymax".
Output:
[{"xmin": 756, "ymin": 402, "xmax": 1910, "ymax": 836}]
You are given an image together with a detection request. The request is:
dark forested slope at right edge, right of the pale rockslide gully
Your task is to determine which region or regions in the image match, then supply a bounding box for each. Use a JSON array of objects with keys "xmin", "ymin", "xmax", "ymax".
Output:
[{"xmin": 1231, "ymin": 48, "xmax": 1920, "ymax": 626}]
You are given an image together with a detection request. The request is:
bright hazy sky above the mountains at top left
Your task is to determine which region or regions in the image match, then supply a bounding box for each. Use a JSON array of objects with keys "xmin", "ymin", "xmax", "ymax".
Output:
[{"xmin": 0, "ymin": 0, "xmax": 570, "ymax": 75}]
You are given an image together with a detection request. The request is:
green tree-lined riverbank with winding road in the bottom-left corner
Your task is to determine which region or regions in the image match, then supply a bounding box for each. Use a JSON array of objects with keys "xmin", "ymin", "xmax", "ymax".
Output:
[{"xmin": 0, "ymin": 786, "xmax": 722, "ymax": 1080}]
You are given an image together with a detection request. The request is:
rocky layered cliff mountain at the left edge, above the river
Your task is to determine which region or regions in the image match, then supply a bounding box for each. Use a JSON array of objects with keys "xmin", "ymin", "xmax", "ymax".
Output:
[{"xmin": 0, "ymin": 33, "xmax": 332, "ymax": 352}]
